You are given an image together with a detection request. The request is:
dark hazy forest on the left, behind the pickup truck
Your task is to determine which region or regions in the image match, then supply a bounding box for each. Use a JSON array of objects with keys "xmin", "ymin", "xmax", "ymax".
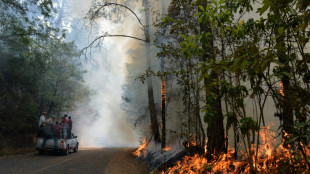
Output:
[{"xmin": 0, "ymin": 0, "xmax": 90, "ymax": 153}]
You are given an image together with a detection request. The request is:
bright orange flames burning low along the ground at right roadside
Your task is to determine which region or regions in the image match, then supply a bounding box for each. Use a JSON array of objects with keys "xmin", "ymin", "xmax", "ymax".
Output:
[{"xmin": 133, "ymin": 127, "xmax": 310, "ymax": 174}]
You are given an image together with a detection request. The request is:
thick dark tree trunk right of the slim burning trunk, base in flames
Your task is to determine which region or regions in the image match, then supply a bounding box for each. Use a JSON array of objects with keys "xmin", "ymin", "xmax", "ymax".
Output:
[{"xmin": 199, "ymin": 0, "xmax": 225, "ymax": 158}]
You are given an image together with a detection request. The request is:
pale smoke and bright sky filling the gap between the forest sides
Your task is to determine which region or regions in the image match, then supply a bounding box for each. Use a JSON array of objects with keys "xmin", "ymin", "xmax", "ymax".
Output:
[{"xmin": 54, "ymin": 0, "xmax": 169, "ymax": 147}]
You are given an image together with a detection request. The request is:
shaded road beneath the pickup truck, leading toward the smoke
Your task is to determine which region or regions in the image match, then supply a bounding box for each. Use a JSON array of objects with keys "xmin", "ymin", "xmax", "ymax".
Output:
[{"xmin": 0, "ymin": 148, "xmax": 148, "ymax": 174}]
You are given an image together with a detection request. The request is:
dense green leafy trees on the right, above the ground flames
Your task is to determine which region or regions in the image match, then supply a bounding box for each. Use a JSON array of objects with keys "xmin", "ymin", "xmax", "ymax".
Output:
[{"xmin": 152, "ymin": 0, "xmax": 310, "ymax": 173}]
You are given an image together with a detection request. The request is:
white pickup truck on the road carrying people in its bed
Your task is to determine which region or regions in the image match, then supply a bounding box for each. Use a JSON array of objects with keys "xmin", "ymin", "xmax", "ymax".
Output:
[{"xmin": 36, "ymin": 134, "xmax": 79, "ymax": 155}]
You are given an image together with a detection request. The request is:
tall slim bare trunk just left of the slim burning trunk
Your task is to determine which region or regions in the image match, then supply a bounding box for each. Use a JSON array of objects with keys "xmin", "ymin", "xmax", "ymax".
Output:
[{"xmin": 144, "ymin": 0, "xmax": 160, "ymax": 142}]
